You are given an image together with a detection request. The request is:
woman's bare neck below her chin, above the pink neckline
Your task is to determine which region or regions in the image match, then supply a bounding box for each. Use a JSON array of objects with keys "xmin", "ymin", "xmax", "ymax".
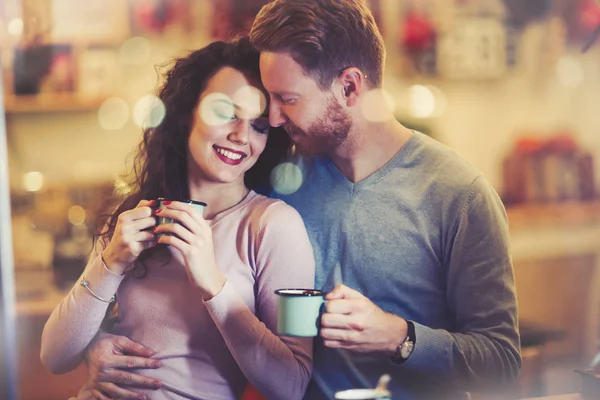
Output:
[{"xmin": 190, "ymin": 182, "xmax": 249, "ymax": 219}]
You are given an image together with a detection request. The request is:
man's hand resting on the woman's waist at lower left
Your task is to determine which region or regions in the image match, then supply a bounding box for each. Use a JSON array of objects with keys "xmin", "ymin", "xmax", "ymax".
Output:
[{"xmin": 84, "ymin": 332, "xmax": 162, "ymax": 400}]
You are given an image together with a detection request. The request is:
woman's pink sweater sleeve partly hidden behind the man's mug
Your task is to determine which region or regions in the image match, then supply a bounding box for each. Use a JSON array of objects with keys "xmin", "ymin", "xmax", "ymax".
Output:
[{"xmin": 205, "ymin": 202, "xmax": 315, "ymax": 399}]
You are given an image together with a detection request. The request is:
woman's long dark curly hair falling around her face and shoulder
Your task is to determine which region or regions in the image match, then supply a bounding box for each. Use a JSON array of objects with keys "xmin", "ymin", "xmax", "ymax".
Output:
[{"xmin": 98, "ymin": 38, "xmax": 290, "ymax": 261}]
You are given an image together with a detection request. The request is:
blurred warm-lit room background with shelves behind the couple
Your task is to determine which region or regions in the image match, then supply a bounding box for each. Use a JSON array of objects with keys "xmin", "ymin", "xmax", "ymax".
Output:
[{"xmin": 0, "ymin": 0, "xmax": 600, "ymax": 400}]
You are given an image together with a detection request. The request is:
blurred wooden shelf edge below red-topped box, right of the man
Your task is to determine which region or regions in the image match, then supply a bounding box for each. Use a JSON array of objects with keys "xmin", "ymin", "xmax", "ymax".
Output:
[{"xmin": 506, "ymin": 200, "xmax": 600, "ymax": 229}]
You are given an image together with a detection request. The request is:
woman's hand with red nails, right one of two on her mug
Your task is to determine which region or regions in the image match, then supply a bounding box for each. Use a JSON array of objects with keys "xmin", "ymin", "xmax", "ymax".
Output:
[{"xmin": 154, "ymin": 201, "xmax": 226, "ymax": 300}]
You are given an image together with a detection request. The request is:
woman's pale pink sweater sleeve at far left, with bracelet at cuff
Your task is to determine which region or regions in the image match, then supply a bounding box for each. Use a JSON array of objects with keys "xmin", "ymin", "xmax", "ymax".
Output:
[{"xmin": 40, "ymin": 242, "xmax": 123, "ymax": 374}]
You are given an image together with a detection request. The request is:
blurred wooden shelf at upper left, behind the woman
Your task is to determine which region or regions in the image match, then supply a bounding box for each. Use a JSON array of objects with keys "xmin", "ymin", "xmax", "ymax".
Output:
[{"xmin": 4, "ymin": 93, "xmax": 104, "ymax": 114}]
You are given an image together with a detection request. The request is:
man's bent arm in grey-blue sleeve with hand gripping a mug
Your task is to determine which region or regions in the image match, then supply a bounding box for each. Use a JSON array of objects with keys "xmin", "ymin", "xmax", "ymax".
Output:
[{"xmin": 321, "ymin": 178, "xmax": 521, "ymax": 390}]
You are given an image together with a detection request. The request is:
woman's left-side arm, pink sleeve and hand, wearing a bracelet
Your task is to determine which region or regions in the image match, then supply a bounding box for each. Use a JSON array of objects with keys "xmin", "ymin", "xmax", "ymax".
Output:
[{"xmin": 40, "ymin": 200, "xmax": 156, "ymax": 374}]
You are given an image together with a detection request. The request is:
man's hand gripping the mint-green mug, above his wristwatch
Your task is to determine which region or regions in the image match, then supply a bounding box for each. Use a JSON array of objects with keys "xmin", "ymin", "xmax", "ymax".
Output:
[{"xmin": 320, "ymin": 285, "xmax": 408, "ymax": 356}]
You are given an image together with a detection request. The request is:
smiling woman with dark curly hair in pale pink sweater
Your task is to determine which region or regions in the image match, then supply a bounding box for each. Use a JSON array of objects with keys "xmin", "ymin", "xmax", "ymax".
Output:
[{"xmin": 41, "ymin": 39, "xmax": 314, "ymax": 399}]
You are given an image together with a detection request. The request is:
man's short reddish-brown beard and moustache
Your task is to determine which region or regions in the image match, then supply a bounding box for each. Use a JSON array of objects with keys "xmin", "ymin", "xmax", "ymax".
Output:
[{"xmin": 284, "ymin": 98, "xmax": 352, "ymax": 157}]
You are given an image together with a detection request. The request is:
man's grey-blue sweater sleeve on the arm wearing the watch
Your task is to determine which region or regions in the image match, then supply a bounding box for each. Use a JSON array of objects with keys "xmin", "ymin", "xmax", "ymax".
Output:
[{"xmin": 401, "ymin": 176, "xmax": 521, "ymax": 390}]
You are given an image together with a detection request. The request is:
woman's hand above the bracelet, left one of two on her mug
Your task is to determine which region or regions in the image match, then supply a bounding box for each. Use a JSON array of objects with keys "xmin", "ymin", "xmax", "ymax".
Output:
[{"xmin": 102, "ymin": 200, "xmax": 156, "ymax": 275}]
